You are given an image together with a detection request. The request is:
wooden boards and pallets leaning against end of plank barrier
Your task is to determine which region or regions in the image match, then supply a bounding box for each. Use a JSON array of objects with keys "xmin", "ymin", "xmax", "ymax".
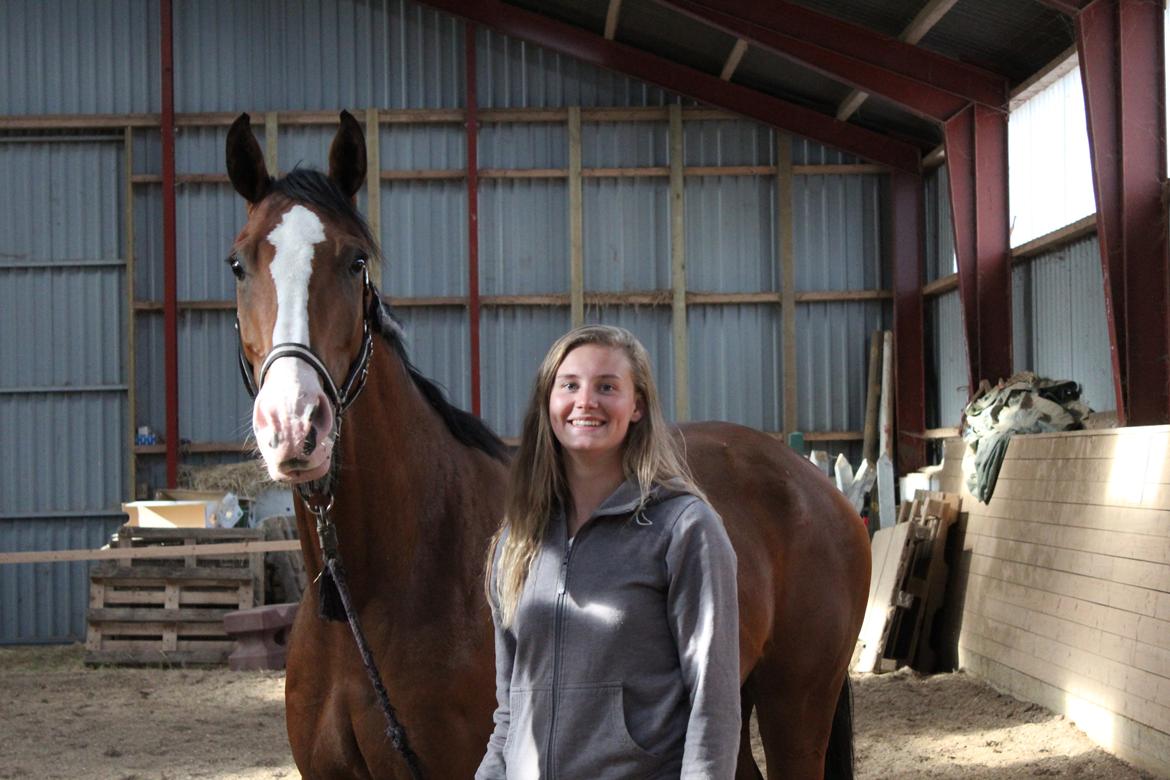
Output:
[{"xmin": 853, "ymin": 490, "xmax": 959, "ymax": 671}]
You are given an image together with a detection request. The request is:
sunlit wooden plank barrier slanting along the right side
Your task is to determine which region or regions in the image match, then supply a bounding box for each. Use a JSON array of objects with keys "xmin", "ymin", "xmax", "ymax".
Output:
[{"xmin": 942, "ymin": 427, "xmax": 1170, "ymax": 775}]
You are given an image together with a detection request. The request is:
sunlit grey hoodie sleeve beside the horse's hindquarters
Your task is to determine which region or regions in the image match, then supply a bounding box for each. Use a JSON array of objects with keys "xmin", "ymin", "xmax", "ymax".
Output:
[{"xmin": 666, "ymin": 499, "xmax": 739, "ymax": 780}]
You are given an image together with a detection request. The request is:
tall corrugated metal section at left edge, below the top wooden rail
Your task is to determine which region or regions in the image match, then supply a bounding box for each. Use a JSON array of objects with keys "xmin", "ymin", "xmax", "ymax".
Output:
[{"xmin": 0, "ymin": 138, "xmax": 128, "ymax": 642}]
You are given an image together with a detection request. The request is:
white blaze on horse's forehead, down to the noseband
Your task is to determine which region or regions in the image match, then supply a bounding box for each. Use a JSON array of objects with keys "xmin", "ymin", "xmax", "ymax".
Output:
[{"xmin": 268, "ymin": 206, "xmax": 325, "ymax": 346}]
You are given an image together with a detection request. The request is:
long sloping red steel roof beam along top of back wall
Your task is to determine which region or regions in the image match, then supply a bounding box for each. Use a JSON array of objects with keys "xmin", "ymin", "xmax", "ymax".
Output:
[{"xmin": 424, "ymin": 0, "xmax": 922, "ymax": 173}]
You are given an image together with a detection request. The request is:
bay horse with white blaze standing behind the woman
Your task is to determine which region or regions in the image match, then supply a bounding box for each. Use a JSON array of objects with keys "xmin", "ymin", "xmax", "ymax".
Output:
[{"xmin": 227, "ymin": 111, "xmax": 869, "ymax": 779}]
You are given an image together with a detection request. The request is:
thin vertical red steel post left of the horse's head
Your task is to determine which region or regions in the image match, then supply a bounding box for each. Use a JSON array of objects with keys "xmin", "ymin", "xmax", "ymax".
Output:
[{"xmin": 160, "ymin": 0, "xmax": 179, "ymax": 488}]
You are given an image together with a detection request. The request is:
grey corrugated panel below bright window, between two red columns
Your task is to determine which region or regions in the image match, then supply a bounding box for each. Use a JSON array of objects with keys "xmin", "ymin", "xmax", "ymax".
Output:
[{"xmin": 1013, "ymin": 236, "xmax": 1117, "ymax": 409}]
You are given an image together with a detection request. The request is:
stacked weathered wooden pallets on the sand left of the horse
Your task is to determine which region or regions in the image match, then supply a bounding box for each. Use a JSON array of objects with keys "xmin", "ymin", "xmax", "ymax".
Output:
[{"xmin": 85, "ymin": 526, "xmax": 264, "ymax": 665}]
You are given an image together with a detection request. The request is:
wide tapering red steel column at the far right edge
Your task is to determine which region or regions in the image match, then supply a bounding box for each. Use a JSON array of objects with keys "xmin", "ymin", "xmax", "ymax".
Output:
[{"xmin": 1076, "ymin": 0, "xmax": 1170, "ymax": 424}]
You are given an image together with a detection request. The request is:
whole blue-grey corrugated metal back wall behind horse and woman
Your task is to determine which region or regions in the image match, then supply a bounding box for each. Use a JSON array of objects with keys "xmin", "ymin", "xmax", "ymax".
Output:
[{"xmin": 0, "ymin": 0, "xmax": 890, "ymax": 643}]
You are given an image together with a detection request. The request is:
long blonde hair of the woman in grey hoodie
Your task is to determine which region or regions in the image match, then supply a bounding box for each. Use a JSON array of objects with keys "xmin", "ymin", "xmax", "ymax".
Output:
[{"xmin": 486, "ymin": 325, "xmax": 703, "ymax": 627}]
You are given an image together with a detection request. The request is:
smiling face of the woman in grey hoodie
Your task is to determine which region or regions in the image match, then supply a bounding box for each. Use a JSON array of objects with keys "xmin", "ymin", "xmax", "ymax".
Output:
[{"xmin": 549, "ymin": 344, "xmax": 642, "ymax": 467}]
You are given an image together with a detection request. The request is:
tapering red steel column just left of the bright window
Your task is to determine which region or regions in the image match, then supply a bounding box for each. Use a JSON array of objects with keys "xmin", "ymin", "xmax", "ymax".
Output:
[{"xmin": 943, "ymin": 105, "xmax": 1012, "ymax": 394}]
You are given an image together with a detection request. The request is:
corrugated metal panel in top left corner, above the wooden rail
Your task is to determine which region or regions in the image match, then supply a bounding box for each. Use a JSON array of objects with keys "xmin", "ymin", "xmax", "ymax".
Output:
[{"xmin": 0, "ymin": 0, "xmax": 159, "ymax": 115}]
